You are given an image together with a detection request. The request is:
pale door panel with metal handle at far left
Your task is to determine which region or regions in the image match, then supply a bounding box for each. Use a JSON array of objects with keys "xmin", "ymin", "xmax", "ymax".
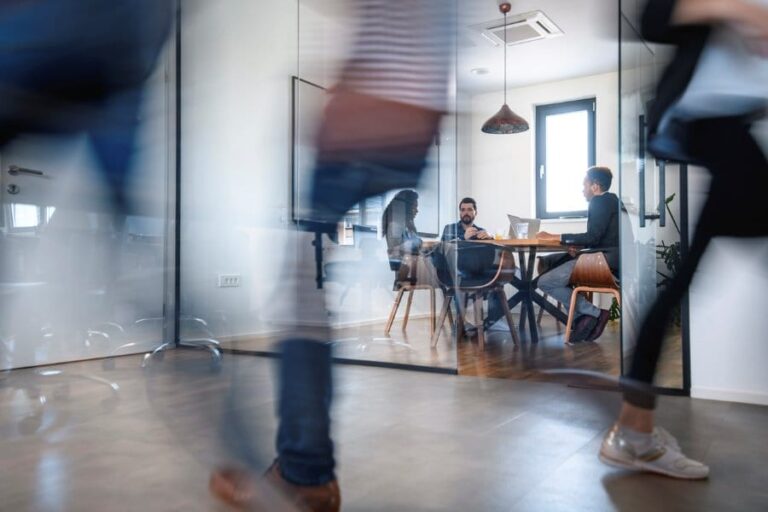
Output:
[{"xmin": 0, "ymin": 44, "xmax": 174, "ymax": 370}]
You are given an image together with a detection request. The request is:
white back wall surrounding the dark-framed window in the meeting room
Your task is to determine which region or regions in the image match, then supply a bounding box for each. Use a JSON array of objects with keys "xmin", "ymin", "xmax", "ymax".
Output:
[{"xmin": 458, "ymin": 73, "xmax": 618, "ymax": 233}]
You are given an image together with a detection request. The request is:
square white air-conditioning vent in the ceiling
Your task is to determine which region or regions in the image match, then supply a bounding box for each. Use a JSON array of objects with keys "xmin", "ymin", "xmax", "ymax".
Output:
[{"xmin": 469, "ymin": 11, "xmax": 563, "ymax": 46}]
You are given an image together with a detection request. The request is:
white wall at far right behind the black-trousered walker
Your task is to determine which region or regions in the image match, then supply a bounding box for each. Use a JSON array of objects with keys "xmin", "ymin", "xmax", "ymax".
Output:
[{"xmin": 689, "ymin": 124, "xmax": 768, "ymax": 405}]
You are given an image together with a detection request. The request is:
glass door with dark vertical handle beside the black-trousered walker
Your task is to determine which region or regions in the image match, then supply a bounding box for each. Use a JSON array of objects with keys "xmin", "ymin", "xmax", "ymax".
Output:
[{"xmin": 619, "ymin": 0, "xmax": 689, "ymax": 392}]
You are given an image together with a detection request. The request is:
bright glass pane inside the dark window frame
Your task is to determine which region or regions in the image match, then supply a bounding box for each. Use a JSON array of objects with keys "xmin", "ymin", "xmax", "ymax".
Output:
[{"xmin": 546, "ymin": 110, "xmax": 589, "ymax": 212}]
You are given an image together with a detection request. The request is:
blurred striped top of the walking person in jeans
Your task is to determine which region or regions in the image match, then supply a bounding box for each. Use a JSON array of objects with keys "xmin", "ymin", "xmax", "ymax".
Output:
[{"xmin": 342, "ymin": 0, "xmax": 456, "ymax": 112}]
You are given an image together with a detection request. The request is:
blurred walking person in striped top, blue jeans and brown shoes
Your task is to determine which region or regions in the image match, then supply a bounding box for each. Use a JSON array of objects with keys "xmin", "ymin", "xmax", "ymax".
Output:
[{"xmin": 210, "ymin": 0, "xmax": 455, "ymax": 512}]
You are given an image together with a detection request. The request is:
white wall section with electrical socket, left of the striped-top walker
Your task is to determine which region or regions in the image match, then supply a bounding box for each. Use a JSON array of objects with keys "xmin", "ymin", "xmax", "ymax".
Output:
[{"xmin": 180, "ymin": 0, "xmax": 298, "ymax": 335}]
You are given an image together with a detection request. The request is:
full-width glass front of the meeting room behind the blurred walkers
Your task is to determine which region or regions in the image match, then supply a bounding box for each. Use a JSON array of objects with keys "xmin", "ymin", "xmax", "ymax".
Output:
[{"xmin": 0, "ymin": 0, "xmax": 688, "ymax": 389}]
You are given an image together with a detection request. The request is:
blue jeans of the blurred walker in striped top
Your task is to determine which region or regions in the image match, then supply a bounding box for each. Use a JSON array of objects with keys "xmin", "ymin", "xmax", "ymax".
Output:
[{"xmin": 277, "ymin": 154, "xmax": 426, "ymax": 486}]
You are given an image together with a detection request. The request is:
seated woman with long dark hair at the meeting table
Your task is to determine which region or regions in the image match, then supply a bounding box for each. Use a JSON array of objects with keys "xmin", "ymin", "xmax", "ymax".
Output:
[{"xmin": 381, "ymin": 190, "xmax": 437, "ymax": 289}]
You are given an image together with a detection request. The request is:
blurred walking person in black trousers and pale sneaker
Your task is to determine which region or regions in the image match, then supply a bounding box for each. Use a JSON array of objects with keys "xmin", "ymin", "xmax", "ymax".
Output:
[{"xmin": 600, "ymin": 0, "xmax": 768, "ymax": 479}]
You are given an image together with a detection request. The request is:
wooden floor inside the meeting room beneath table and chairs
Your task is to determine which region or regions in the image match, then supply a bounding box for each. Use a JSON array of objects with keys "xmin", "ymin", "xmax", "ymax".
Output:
[{"xmin": 219, "ymin": 315, "xmax": 683, "ymax": 388}]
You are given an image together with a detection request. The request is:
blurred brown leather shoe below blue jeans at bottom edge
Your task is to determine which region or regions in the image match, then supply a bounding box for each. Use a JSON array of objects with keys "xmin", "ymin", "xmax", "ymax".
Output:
[{"xmin": 209, "ymin": 463, "xmax": 341, "ymax": 512}]
